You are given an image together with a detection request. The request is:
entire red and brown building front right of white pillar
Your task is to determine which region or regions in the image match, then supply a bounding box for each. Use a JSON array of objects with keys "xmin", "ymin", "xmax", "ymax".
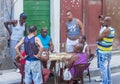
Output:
[{"xmin": 60, "ymin": 0, "xmax": 120, "ymax": 52}]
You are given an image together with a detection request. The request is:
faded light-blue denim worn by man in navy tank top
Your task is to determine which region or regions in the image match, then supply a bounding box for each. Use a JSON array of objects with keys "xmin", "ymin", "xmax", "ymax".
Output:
[{"xmin": 25, "ymin": 60, "xmax": 43, "ymax": 84}]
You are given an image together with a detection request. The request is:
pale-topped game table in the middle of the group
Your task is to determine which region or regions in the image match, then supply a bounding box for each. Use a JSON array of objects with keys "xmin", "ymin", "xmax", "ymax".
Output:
[{"xmin": 49, "ymin": 52, "xmax": 73, "ymax": 84}]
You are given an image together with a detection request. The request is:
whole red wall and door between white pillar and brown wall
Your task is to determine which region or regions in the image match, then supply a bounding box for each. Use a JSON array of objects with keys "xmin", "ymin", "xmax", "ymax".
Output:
[{"xmin": 60, "ymin": 0, "xmax": 105, "ymax": 51}]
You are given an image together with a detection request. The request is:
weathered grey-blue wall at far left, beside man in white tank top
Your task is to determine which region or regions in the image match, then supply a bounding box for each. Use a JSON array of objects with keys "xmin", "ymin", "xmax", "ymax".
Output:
[{"xmin": 0, "ymin": 0, "xmax": 13, "ymax": 69}]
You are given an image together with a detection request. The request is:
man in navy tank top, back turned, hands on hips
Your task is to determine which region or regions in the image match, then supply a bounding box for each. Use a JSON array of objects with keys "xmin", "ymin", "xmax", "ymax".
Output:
[{"xmin": 15, "ymin": 26, "xmax": 45, "ymax": 84}]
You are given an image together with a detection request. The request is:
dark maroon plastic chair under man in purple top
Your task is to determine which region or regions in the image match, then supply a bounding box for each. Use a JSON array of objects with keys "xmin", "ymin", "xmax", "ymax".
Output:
[{"xmin": 70, "ymin": 63, "xmax": 90, "ymax": 84}]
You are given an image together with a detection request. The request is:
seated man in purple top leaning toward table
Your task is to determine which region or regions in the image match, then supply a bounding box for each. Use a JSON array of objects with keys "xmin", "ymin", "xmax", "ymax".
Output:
[{"xmin": 63, "ymin": 43, "xmax": 87, "ymax": 83}]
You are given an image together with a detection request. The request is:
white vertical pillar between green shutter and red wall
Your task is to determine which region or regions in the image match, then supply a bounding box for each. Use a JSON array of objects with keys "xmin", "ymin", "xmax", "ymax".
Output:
[{"xmin": 50, "ymin": 0, "xmax": 60, "ymax": 52}]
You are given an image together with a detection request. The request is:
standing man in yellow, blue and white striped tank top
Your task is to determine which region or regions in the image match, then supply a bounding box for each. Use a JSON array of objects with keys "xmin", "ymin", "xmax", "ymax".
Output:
[{"xmin": 97, "ymin": 16, "xmax": 115, "ymax": 84}]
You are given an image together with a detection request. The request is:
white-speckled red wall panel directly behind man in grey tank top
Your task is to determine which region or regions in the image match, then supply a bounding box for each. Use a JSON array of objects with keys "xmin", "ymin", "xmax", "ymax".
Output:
[{"xmin": 60, "ymin": 0, "xmax": 83, "ymax": 43}]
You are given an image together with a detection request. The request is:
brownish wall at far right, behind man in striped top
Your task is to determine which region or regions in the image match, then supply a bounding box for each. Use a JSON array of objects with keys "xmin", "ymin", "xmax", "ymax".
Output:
[{"xmin": 105, "ymin": 0, "xmax": 120, "ymax": 50}]
